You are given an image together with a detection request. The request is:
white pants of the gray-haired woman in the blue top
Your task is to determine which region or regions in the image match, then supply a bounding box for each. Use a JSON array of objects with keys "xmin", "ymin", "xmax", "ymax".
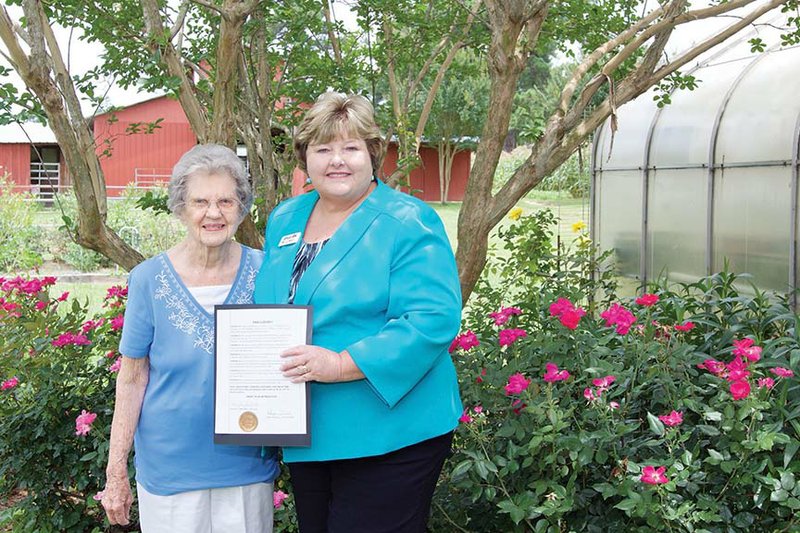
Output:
[{"xmin": 136, "ymin": 483, "xmax": 273, "ymax": 533}]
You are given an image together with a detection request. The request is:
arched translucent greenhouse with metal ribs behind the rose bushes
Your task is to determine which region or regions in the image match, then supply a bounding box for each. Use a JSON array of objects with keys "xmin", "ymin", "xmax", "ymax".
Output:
[{"xmin": 591, "ymin": 21, "xmax": 800, "ymax": 292}]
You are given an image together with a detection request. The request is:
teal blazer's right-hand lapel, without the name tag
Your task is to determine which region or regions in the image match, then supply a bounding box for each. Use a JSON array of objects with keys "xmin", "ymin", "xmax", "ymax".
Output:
[{"xmin": 290, "ymin": 182, "xmax": 386, "ymax": 305}]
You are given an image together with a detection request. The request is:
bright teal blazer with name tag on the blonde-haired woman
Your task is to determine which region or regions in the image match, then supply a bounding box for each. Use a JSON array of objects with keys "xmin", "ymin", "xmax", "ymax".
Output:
[{"xmin": 254, "ymin": 183, "xmax": 462, "ymax": 462}]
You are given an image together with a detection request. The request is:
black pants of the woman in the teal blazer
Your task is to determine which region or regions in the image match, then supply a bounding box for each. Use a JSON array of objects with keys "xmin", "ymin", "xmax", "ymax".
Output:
[{"xmin": 289, "ymin": 432, "xmax": 453, "ymax": 533}]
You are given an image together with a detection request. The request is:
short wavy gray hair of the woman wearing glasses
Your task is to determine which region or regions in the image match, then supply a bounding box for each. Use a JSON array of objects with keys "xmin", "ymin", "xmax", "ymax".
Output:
[{"xmin": 167, "ymin": 144, "xmax": 253, "ymax": 220}]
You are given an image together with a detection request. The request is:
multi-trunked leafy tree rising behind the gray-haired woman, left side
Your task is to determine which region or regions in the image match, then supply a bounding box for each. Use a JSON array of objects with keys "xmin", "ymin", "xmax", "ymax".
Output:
[{"xmin": 0, "ymin": 0, "xmax": 363, "ymax": 269}]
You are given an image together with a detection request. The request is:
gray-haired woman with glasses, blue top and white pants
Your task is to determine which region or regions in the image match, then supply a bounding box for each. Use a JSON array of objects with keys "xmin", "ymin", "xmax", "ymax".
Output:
[{"xmin": 103, "ymin": 145, "xmax": 278, "ymax": 533}]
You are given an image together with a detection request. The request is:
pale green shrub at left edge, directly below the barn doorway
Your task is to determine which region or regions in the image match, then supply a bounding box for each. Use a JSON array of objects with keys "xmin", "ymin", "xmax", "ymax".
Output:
[{"xmin": 0, "ymin": 176, "xmax": 43, "ymax": 272}]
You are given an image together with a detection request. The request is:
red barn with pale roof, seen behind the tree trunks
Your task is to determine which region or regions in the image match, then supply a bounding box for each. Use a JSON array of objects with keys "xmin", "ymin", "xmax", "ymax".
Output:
[{"xmin": 0, "ymin": 96, "xmax": 471, "ymax": 202}]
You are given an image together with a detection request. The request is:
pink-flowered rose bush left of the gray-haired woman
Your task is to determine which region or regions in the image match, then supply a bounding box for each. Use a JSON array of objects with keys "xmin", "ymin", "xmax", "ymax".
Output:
[{"xmin": 0, "ymin": 277, "xmax": 126, "ymax": 533}]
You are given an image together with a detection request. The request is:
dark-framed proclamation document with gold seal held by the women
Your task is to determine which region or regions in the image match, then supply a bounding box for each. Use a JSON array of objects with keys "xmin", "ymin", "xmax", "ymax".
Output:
[{"xmin": 214, "ymin": 305, "xmax": 312, "ymax": 446}]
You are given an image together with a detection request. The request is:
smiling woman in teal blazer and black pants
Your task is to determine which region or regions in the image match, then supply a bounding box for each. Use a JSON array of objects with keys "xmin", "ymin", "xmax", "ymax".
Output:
[{"xmin": 255, "ymin": 93, "xmax": 461, "ymax": 533}]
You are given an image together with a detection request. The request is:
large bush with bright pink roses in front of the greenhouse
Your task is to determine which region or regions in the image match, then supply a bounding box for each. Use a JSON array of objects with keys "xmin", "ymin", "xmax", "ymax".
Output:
[{"xmin": 431, "ymin": 210, "xmax": 800, "ymax": 532}]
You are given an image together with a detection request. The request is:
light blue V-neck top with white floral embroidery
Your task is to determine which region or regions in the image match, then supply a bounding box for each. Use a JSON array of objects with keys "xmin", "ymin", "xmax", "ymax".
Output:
[{"xmin": 119, "ymin": 246, "xmax": 278, "ymax": 495}]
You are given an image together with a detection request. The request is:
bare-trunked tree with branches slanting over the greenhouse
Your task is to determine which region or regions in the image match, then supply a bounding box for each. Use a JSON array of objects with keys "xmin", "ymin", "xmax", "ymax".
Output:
[{"xmin": 456, "ymin": 0, "xmax": 800, "ymax": 302}]
